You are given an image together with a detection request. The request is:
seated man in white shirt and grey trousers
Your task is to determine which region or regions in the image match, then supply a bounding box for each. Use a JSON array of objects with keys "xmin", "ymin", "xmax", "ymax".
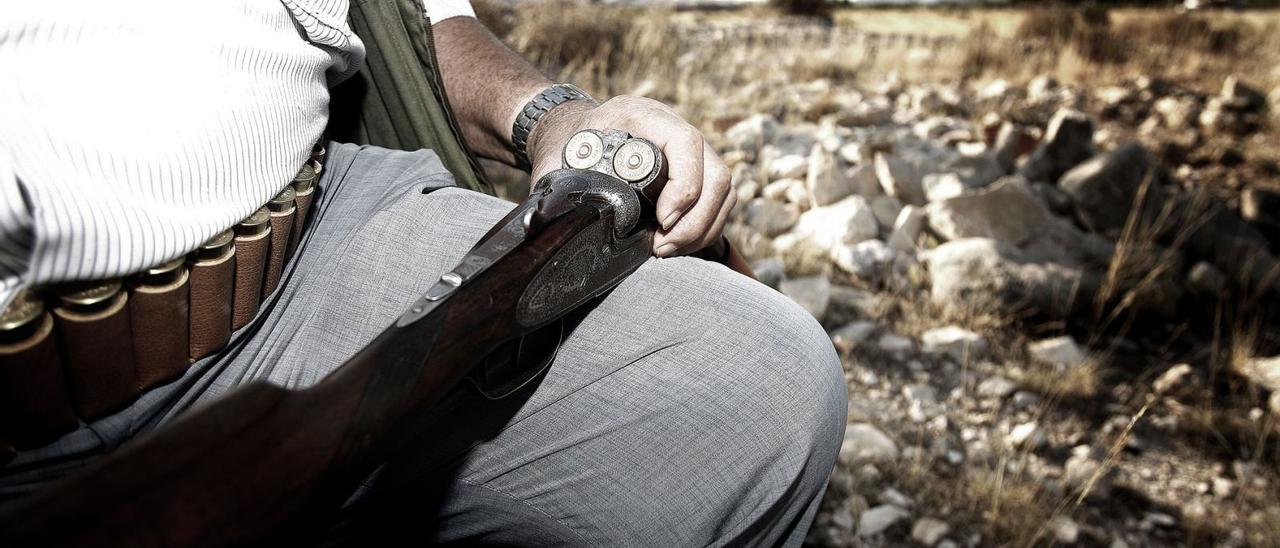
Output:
[{"xmin": 0, "ymin": 0, "xmax": 846, "ymax": 545}]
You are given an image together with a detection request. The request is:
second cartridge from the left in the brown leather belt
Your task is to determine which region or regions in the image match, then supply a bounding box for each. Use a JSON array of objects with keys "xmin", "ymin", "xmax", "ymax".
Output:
[{"xmin": 54, "ymin": 280, "xmax": 138, "ymax": 420}]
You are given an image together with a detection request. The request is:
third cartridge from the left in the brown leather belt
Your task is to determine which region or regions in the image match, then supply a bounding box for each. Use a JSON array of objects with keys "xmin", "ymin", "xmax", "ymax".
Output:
[{"xmin": 129, "ymin": 257, "xmax": 191, "ymax": 391}]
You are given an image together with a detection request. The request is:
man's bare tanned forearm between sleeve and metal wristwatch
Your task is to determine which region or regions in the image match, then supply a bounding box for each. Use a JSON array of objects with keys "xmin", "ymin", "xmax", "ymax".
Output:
[{"xmin": 431, "ymin": 17, "xmax": 552, "ymax": 164}]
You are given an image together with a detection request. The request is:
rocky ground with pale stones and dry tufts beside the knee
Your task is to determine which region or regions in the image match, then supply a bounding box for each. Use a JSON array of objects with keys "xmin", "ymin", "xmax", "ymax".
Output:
[{"xmin": 717, "ymin": 78, "xmax": 1280, "ymax": 547}]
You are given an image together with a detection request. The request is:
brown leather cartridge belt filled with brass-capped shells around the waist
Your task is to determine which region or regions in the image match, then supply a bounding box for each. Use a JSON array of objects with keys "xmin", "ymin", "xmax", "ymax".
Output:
[{"xmin": 0, "ymin": 146, "xmax": 324, "ymax": 465}]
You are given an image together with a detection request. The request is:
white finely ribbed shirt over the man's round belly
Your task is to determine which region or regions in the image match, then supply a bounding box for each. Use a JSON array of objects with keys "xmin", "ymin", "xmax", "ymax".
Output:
[{"xmin": 0, "ymin": 0, "xmax": 471, "ymax": 307}]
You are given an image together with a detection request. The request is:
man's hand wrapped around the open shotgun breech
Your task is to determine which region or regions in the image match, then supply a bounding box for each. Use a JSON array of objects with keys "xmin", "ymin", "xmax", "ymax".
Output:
[{"xmin": 529, "ymin": 95, "xmax": 737, "ymax": 257}]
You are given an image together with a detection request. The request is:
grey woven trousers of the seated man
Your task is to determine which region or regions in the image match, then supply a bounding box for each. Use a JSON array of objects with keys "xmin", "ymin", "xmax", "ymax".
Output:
[{"xmin": 10, "ymin": 145, "xmax": 846, "ymax": 547}]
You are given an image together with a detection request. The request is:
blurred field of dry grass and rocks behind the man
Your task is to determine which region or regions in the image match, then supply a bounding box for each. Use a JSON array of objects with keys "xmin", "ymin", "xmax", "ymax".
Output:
[{"xmin": 474, "ymin": 0, "xmax": 1280, "ymax": 547}]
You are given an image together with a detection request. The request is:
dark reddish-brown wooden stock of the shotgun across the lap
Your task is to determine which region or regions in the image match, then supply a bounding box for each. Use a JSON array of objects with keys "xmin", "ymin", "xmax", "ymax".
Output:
[{"xmin": 0, "ymin": 204, "xmax": 609, "ymax": 547}]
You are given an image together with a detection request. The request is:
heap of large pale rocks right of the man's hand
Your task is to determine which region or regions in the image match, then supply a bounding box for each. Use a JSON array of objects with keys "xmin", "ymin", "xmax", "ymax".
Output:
[{"xmin": 722, "ymin": 78, "xmax": 1280, "ymax": 327}]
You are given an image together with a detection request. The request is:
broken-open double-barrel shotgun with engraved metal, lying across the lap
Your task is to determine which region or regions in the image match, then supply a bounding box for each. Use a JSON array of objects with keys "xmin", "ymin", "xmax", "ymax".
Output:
[{"xmin": 0, "ymin": 129, "xmax": 666, "ymax": 547}]
